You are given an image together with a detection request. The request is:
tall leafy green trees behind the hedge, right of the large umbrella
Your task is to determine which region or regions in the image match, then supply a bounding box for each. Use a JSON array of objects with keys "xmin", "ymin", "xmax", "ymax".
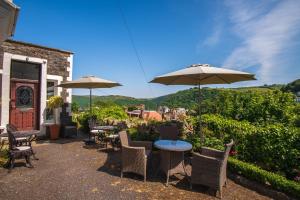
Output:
[{"xmin": 201, "ymin": 89, "xmax": 297, "ymax": 124}]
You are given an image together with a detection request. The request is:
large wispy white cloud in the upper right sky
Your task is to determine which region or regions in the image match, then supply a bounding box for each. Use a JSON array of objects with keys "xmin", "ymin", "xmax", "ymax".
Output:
[{"xmin": 223, "ymin": 0, "xmax": 300, "ymax": 83}]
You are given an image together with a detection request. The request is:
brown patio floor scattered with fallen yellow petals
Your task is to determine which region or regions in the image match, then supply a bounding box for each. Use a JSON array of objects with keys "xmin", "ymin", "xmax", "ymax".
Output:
[{"xmin": 0, "ymin": 139, "xmax": 269, "ymax": 200}]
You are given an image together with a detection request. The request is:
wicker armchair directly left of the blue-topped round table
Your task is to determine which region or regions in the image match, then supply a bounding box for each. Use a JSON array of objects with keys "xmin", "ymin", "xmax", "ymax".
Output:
[{"xmin": 119, "ymin": 131, "xmax": 152, "ymax": 181}]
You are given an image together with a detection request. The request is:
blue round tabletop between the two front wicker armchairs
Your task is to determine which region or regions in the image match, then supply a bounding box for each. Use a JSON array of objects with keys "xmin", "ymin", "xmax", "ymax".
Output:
[{"xmin": 154, "ymin": 140, "xmax": 193, "ymax": 151}]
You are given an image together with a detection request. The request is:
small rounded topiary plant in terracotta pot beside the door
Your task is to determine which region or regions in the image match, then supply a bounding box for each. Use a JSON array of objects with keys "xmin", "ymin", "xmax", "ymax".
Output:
[{"xmin": 47, "ymin": 96, "xmax": 64, "ymax": 140}]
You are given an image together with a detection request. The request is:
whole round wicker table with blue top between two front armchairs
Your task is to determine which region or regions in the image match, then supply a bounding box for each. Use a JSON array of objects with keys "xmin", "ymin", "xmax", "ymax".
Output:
[{"xmin": 154, "ymin": 140, "xmax": 193, "ymax": 185}]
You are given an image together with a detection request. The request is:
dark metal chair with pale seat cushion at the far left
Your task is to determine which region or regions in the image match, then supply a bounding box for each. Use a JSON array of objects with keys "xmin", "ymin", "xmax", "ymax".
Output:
[{"xmin": 7, "ymin": 129, "xmax": 33, "ymax": 170}]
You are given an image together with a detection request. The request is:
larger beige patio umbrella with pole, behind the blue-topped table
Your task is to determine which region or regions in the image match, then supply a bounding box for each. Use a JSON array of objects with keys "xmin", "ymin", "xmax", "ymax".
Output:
[{"xmin": 150, "ymin": 64, "xmax": 256, "ymax": 142}]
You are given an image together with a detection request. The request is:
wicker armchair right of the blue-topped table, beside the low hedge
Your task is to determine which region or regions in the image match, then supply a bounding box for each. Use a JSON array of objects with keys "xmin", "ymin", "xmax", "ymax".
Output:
[{"xmin": 190, "ymin": 140, "xmax": 234, "ymax": 198}]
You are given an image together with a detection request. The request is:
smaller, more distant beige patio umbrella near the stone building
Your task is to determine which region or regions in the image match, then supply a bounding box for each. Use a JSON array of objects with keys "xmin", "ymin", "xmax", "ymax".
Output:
[{"xmin": 57, "ymin": 76, "xmax": 121, "ymax": 113}]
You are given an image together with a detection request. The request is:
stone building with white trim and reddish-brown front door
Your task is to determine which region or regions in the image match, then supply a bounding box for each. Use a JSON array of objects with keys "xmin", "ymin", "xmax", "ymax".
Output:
[{"xmin": 0, "ymin": 40, "xmax": 73, "ymax": 134}]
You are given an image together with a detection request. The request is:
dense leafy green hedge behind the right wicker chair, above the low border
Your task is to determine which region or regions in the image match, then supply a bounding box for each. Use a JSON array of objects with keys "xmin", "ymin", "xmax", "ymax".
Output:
[{"xmin": 195, "ymin": 115, "xmax": 300, "ymax": 178}]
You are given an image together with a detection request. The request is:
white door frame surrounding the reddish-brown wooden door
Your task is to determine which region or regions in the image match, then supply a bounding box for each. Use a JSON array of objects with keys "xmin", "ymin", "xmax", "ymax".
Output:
[{"xmin": 1, "ymin": 52, "xmax": 48, "ymax": 133}]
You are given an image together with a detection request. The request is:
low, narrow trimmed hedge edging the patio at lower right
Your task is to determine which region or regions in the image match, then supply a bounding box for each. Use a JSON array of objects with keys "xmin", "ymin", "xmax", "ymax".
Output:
[{"xmin": 228, "ymin": 157, "xmax": 300, "ymax": 198}]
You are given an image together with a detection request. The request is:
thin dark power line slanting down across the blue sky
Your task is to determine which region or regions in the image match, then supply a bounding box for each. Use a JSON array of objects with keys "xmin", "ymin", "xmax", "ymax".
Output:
[{"xmin": 117, "ymin": 0, "xmax": 154, "ymax": 96}]
